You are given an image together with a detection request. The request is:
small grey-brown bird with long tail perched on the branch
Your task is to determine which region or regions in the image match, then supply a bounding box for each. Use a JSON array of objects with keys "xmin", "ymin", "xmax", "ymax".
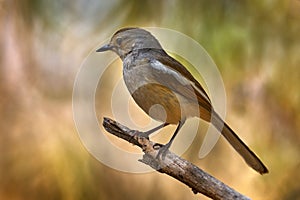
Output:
[{"xmin": 96, "ymin": 27, "xmax": 268, "ymax": 174}]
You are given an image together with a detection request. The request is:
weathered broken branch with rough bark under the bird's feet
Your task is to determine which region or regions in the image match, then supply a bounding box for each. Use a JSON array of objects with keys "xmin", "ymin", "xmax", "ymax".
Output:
[{"xmin": 103, "ymin": 118, "xmax": 249, "ymax": 199}]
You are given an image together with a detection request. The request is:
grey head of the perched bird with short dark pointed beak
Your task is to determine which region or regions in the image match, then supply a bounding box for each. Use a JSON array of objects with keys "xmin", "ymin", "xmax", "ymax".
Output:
[{"xmin": 97, "ymin": 28, "xmax": 162, "ymax": 60}]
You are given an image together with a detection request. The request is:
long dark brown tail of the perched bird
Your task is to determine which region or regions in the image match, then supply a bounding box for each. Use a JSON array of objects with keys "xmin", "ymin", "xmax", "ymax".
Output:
[{"xmin": 212, "ymin": 113, "xmax": 269, "ymax": 174}]
